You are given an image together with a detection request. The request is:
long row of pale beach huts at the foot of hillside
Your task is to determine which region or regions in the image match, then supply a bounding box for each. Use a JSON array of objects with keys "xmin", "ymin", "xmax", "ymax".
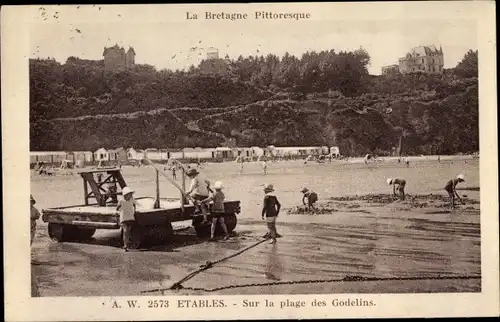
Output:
[{"xmin": 30, "ymin": 146, "xmax": 339, "ymax": 164}]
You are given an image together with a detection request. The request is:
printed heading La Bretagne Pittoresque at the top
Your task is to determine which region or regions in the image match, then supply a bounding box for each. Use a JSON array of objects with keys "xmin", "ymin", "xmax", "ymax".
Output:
[{"xmin": 186, "ymin": 11, "xmax": 311, "ymax": 21}]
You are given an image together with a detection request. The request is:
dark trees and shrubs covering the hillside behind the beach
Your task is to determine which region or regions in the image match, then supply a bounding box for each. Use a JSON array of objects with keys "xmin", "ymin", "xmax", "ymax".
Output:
[{"xmin": 30, "ymin": 49, "xmax": 479, "ymax": 155}]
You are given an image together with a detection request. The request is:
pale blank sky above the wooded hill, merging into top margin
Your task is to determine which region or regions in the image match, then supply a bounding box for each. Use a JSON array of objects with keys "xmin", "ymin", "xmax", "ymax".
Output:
[{"xmin": 26, "ymin": 6, "xmax": 478, "ymax": 75}]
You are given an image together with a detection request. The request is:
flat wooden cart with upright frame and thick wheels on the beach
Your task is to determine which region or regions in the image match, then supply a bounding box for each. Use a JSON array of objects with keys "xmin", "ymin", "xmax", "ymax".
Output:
[{"xmin": 42, "ymin": 168, "xmax": 240, "ymax": 248}]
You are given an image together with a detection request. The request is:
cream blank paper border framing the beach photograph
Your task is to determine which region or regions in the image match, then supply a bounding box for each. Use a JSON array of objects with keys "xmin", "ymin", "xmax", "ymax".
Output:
[{"xmin": 1, "ymin": 1, "xmax": 499, "ymax": 321}]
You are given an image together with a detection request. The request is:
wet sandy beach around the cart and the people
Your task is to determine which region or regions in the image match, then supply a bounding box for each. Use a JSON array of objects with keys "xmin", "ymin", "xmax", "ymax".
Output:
[{"xmin": 32, "ymin": 159, "xmax": 481, "ymax": 296}]
